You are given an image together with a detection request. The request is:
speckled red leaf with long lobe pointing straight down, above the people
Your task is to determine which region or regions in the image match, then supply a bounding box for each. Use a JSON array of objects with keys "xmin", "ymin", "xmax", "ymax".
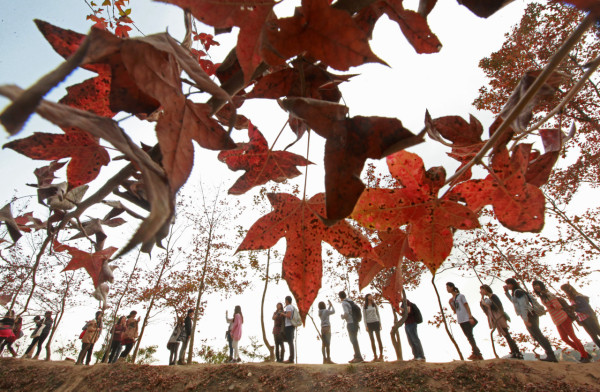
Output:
[{"xmin": 237, "ymin": 193, "xmax": 375, "ymax": 320}]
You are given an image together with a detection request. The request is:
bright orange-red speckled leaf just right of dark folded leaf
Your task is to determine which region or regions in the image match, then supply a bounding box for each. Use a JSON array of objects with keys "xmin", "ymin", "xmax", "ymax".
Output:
[{"xmin": 352, "ymin": 151, "xmax": 479, "ymax": 273}]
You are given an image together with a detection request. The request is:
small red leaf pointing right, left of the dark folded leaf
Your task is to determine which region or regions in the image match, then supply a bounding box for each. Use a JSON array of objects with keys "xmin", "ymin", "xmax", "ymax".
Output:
[{"xmin": 218, "ymin": 123, "xmax": 312, "ymax": 195}]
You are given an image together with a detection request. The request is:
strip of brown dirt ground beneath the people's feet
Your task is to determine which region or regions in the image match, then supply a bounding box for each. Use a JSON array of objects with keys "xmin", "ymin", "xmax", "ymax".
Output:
[{"xmin": 0, "ymin": 358, "xmax": 600, "ymax": 392}]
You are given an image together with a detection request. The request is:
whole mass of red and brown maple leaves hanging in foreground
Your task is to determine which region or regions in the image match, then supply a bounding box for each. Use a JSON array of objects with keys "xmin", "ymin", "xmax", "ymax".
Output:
[{"xmin": 0, "ymin": 0, "xmax": 598, "ymax": 324}]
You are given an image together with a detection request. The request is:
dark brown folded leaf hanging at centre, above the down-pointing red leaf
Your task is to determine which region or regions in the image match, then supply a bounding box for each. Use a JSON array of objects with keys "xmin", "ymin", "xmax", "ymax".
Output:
[{"xmin": 282, "ymin": 98, "xmax": 422, "ymax": 222}]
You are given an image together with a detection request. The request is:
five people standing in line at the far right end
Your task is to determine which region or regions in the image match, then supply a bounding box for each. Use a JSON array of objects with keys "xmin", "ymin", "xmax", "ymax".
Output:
[{"xmin": 446, "ymin": 278, "xmax": 600, "ymax": 363}]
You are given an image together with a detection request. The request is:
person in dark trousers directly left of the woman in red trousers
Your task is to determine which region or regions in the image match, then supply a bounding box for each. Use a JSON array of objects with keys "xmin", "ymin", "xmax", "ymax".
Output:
[{"xmin": 504, "ymin": 278, "xmax": 558, "ymax": 362}]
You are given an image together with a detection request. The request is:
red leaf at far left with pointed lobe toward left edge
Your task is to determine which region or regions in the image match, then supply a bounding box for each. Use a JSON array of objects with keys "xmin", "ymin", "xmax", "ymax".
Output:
[{"xmin": 4, "ymin": 132, "xmax": 110, "ymax": 187}]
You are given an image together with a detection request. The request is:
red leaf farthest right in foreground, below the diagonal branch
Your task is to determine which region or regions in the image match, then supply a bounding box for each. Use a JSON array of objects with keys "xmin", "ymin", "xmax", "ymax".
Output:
[{"xmin": 449, "ymin": 145, "xmax": 546, "ymax": 233}]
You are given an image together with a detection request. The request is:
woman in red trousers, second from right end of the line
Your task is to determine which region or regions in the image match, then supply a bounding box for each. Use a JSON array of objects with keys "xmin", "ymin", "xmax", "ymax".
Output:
[{"xmin": 532, "ymin": 280, "xmax": 590, "ymax": 363}]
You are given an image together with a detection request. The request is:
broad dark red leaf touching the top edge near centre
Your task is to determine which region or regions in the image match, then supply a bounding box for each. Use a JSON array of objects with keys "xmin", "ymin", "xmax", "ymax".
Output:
[{"xmin": 262, "ymin": 0, "xmax": 385, "ymax": 71}]
